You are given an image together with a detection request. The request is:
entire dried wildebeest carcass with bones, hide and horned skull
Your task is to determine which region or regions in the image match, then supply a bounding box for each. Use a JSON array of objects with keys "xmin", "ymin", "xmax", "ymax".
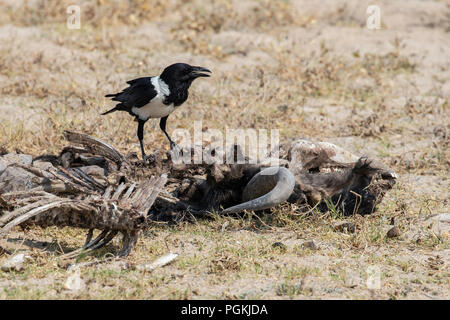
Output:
[{"xmin": 0, "ymin": 131, "xmax": 395, "ymax": 257}]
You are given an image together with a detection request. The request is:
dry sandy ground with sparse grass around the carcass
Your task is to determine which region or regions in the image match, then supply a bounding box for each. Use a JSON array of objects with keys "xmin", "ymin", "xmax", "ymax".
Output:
[{"xmin": 0, "ymin": 0, "xmax": 450, "ymax": 299}]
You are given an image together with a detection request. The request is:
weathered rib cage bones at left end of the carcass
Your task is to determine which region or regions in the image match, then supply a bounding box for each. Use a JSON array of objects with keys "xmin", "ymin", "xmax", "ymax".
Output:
[{"xmin": 0, "ymin": 132, "xmax": 167, "ymax": 257}]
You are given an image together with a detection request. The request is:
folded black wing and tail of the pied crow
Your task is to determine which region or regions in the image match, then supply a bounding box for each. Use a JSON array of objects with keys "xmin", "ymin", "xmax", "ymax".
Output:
[{"xmin": 105, "ymin": 77, "xmax": 158, "ymax": 111}]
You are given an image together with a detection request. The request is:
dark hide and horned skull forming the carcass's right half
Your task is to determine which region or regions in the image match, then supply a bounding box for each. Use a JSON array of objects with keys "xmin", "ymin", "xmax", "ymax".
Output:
[{"xmin": 159, "ymin": 140, "xmax": 397, "ymax": 218}]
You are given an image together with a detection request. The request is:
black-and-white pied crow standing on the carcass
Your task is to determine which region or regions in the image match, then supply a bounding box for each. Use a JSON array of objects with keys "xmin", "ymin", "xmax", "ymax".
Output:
[{"xmin": 102, "ymin": 63, "xmax": 211, "ymax": 160}]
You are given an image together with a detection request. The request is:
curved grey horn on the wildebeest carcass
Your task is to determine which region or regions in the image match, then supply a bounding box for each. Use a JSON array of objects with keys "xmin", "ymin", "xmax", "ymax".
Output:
[{"xmin": 222, "ymin": 167, "xmax": 295, "ymax": 213}]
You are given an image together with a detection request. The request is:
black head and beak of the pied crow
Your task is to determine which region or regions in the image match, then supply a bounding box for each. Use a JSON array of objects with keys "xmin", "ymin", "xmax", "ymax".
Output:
[{"xmin": 160, "ymin": 63, "xmax": 211, "ymax": 84}]
